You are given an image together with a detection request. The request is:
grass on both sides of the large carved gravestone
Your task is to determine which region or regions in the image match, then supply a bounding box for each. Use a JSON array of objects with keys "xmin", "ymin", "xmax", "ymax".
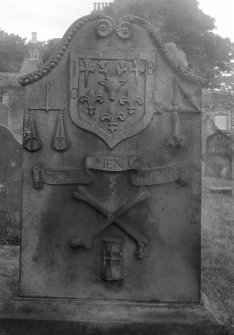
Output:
[{"xmin": 0, "ymin": 178, "xmax": 234, "ymax": 334}]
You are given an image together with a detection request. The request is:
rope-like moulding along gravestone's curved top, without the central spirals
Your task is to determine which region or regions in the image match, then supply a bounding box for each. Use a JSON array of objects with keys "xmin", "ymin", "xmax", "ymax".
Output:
[{"xmin": 18, "ymin": 13, "xmax": 207, "ymax": 86}]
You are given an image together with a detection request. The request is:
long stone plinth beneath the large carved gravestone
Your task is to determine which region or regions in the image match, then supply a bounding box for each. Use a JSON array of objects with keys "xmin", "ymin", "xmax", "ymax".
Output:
[{"xmin": 0, "ymin": 299, "xmax": 229, "ymax": 335}]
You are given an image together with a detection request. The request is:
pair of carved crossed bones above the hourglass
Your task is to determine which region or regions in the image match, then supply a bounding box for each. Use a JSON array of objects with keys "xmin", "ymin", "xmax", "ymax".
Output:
[{"xmin": 70, "ymin": 186, "xmax": 150, "ymax": 259}]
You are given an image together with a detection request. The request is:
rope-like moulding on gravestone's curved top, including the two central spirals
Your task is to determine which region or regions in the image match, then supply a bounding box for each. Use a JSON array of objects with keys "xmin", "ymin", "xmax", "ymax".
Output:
[{"xmin": 18, "ymin": 13, "xmax": 206, "ymax": 86}]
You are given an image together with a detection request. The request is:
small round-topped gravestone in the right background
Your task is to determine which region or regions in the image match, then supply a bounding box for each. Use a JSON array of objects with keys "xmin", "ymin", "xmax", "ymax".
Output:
[{"xmin": 206, "ymin": 130, "xmax": 232, "ymax": 179}]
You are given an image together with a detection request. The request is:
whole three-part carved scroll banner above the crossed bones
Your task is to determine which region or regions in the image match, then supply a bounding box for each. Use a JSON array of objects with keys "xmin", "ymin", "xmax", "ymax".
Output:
[{"xmin": 32, "ymin": 155, "xmax": 186, "ymax": 189}]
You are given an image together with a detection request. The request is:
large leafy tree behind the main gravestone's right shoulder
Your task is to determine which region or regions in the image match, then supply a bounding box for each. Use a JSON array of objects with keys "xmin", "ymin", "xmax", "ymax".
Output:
[{"xmin": 105, "ymin": 0, "xmax": 233, "ymax": 86}]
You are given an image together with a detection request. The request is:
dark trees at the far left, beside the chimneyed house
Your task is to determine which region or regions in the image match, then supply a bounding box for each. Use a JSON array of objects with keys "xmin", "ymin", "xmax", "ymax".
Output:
[{"xmin": 0, "ymin": 29, "xmax": 27, "ymax": 72}]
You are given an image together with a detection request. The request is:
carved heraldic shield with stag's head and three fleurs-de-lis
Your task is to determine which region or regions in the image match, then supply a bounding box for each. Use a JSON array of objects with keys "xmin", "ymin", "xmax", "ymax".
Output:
[{"xmin": 70, "ymin": 51, "xmax": 155, "ymax": 149}]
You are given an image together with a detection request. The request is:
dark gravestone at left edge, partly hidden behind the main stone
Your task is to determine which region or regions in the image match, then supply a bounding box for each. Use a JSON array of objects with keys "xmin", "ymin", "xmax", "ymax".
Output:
[{"xmin": 0, "ymin": 125, "xmax": 22, "ymax": 244}]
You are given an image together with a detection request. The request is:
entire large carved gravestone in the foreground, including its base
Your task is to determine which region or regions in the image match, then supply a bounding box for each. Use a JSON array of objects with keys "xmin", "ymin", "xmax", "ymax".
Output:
[{"xmin": 0, "ymin": 13, "xmax": 227, "ymax": 334}]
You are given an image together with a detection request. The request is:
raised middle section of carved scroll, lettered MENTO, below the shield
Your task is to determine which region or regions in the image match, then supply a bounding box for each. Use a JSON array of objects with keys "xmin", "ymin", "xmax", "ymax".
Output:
[{"xmin": 86, "ymin": 156, "xmax": 142, "ymax": 172}]
